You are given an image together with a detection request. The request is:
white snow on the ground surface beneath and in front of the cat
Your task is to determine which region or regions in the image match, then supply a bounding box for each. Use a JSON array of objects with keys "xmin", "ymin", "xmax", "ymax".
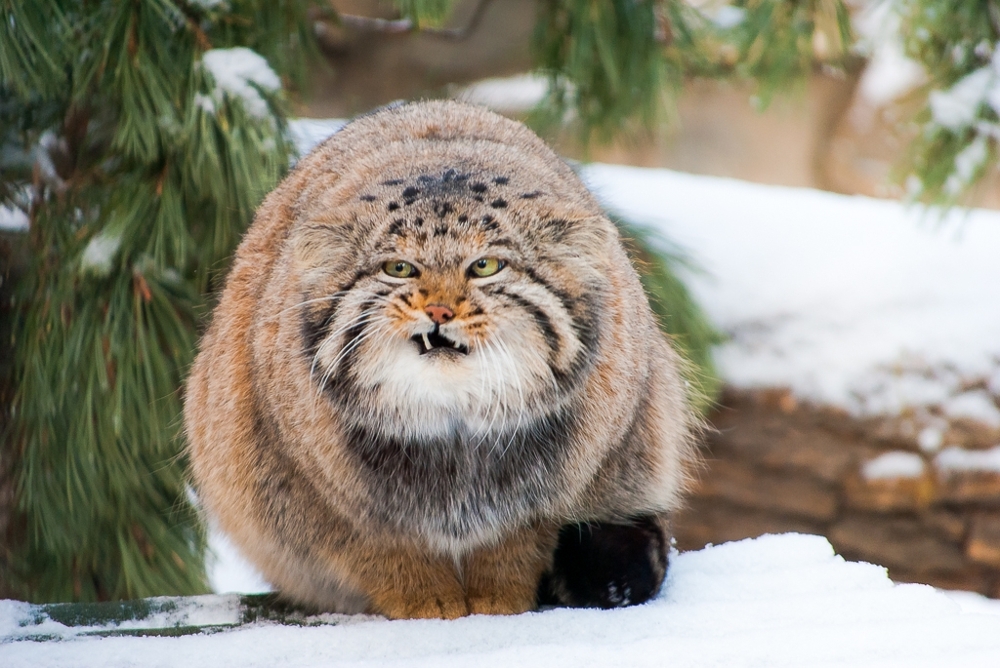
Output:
[{"xmin": 0, "ymin": 534, "xmax": 1000, "ymax": 668}]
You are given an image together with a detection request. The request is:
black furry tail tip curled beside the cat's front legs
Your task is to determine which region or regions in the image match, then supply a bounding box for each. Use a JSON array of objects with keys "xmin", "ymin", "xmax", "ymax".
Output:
[{"xmin": 539, "ymin": 517, "xmax": 667, "ymax": 608}]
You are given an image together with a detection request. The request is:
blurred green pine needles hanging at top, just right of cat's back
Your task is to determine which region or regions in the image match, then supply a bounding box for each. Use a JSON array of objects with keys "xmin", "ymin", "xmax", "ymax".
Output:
[{"xmin": 534, "ymin": 0, "xmax": 852, "ymax": 145}]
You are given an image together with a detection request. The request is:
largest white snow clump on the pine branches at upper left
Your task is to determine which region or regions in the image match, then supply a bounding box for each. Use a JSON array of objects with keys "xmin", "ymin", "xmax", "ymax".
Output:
[{"xmin": 197, "ymin": 46, "xmax": 281, "ymax": 118}]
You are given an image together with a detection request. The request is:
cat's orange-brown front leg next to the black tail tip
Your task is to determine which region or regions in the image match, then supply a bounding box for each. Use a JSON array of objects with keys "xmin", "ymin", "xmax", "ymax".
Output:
[{"xmin": 462, "ymin": 525, "xmax": 558, "ymax": 615}]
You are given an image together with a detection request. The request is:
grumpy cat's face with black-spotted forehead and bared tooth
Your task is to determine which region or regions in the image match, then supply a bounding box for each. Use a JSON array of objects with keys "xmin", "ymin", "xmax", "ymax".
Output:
[{"xmin": 292, "ymin": 166, "xmax": 605, "ymax": 439}]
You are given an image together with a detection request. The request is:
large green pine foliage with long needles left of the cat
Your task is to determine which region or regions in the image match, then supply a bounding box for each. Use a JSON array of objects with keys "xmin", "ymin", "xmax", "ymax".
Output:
[{"xmin": 0, "ymin": 0, "xmax": 315, "ymax": 601}]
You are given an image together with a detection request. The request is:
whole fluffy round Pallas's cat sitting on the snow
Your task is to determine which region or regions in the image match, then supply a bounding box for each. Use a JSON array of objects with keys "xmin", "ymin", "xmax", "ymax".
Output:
[{"xmin": 185, "ymin": 102, "xmax": 698, "ymax": 618}]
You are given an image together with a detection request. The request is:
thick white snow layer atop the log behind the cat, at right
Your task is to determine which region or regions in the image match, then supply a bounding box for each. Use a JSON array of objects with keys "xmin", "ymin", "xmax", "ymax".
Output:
[{"xmin": 583, "ymin": 165, "xmax": 1000, "ymax": 423}]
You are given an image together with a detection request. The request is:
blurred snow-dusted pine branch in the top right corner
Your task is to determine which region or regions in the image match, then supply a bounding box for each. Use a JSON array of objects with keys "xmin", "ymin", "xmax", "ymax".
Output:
[{"xmin": 895, "ymin": 0, "xmax": 1000, "ymax": 205}]
